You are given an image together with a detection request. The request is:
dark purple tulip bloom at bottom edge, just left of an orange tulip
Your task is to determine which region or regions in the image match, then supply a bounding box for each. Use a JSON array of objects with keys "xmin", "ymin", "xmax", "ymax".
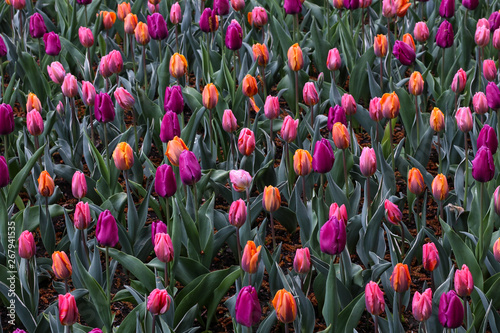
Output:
[{"xmin": 234, "ymin": 286, "xmax": 262, "ymax": 327}]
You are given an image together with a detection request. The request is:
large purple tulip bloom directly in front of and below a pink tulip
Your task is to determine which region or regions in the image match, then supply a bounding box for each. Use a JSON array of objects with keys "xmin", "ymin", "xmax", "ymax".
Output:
[{"xmin": 319, "ymin": 216, "xmax": 347, "ymax": 255}]
